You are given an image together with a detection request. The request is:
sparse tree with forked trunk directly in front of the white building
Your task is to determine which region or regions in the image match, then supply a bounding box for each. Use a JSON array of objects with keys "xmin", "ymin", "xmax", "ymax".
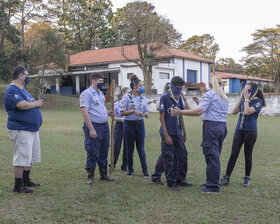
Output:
[{"xmin": 113, "ymin": 1, "xmax": 181, "ymax": 93}]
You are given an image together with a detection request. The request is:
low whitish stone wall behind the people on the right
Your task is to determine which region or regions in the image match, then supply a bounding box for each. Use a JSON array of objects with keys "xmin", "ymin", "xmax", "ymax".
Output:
[{"xmin": 146, "ymin": 94, "xmax": 280, "ymax": 116}]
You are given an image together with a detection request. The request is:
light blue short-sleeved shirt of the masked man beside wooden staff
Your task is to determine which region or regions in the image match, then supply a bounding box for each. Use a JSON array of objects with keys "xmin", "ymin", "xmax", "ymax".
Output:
[{"xmin": 80, "ymin": 86, "xmax": 108, "ymax": 123}]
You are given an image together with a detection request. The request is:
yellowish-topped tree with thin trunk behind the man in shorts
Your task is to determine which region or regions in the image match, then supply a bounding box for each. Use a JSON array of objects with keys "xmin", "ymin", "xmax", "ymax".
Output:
[{"xmin": 26, "ymin": 22, "xmax": 65, "ymax": 98}]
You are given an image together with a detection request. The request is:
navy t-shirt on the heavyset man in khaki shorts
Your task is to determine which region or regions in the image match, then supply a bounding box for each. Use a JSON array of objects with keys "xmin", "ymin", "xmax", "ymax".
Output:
[{"xmin": 4, "ymin": 85, "xmax": 43, "ymax": 132}]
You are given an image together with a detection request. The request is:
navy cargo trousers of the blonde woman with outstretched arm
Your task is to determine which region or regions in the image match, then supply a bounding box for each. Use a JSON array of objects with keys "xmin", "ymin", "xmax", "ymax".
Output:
[{"xmin": 201, "ymin": 121, "xmax": 227, "ymax": 191}]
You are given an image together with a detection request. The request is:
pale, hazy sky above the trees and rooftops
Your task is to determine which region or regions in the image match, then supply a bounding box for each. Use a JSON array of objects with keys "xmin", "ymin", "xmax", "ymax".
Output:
[{"xmin": 111, "ymin": 0, "xmax": 280, "ymax": 63}]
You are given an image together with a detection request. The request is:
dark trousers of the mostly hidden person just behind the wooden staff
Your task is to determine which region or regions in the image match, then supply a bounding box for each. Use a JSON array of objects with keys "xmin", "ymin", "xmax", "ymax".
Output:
[{"xmin": 114, "ymin": 121, "xmax": 127, "ymax": 169}]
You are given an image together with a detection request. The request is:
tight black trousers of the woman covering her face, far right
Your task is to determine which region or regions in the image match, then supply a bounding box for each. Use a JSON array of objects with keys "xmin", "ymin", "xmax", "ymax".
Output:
[{"xmin": 226, "ymin": 130, "xmax": 257, "ymax": 177}]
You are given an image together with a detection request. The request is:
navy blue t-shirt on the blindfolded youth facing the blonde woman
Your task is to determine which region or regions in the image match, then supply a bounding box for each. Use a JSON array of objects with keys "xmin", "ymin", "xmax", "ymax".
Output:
[{"xmin": 159, "ymin": 91, "xmax": 184, "ymax": 135}]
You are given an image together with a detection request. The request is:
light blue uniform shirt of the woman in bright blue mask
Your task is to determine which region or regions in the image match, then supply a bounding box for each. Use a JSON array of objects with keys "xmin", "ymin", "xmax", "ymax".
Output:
[{"xmin": 120, "ymin": 93, "xmax": 149, "ymax": 121}]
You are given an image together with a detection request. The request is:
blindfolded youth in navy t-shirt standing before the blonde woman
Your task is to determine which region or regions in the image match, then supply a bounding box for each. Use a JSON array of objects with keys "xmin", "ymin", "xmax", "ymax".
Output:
[{"xmin": 159, "ymin": 76, "xmax": 192, "ymax": 191}]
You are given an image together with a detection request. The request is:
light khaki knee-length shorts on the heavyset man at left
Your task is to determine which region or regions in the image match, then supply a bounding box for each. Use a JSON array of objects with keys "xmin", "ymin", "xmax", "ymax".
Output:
[{"xmin": 8, "ymin": 130, "xmax": 41, "ymax": 167}]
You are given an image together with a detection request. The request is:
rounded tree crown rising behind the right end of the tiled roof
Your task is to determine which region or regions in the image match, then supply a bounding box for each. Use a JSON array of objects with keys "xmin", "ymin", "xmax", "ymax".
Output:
[{"xmin": 179, "ymin": 34, "xmax": 220, "ymax": 59}]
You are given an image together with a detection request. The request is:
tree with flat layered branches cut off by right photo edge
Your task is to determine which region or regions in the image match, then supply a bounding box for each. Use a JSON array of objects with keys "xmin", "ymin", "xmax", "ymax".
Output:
[{"xmin": 242, "ymin": 25, "xmax": 280, "ymax": 92}]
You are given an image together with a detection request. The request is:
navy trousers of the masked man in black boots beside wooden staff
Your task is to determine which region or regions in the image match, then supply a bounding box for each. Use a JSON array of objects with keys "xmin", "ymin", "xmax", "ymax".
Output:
[{"xmin": 83, "ymin": 122, "xmax": 110, "ymax": 169}]
